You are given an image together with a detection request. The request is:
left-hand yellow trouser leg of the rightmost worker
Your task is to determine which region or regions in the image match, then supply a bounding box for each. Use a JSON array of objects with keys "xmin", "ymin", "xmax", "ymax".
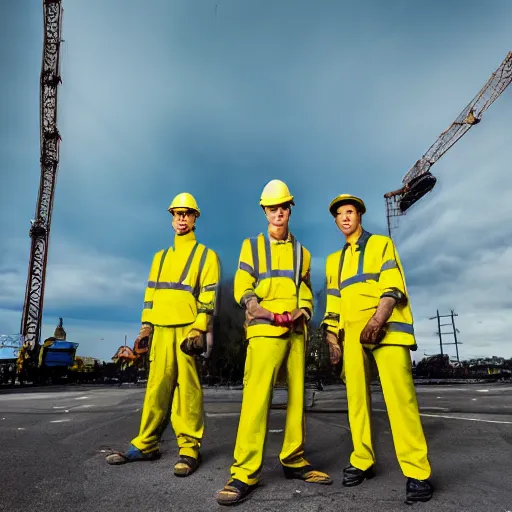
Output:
[{"xmin": 343, "ymin": 325, "xmax": 375, "ymax": 471}]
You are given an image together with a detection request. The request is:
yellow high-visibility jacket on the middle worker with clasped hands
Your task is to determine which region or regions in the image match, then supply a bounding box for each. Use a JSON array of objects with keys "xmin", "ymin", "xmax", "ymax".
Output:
[{"xmin": 234, "ymin": 233, "xmax": 313, "ymax": 339}]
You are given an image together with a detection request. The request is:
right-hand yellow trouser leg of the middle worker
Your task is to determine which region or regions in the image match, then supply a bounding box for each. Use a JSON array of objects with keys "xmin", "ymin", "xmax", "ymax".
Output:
[{"xmin": 279, "ymin": 334, "xmax": 308, "ymax": 468}]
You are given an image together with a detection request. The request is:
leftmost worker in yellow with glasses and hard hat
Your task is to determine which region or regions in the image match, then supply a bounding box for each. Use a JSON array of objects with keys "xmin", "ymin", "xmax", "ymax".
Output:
[{"xmin": 107, "ymin": 193, "xmax": 220, "ymax": 476}]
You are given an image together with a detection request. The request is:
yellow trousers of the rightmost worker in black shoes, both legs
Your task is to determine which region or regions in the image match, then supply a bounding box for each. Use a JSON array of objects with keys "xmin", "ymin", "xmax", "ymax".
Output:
[{"xmin": 343, "ymin": 324, "xmax": 431, "ymax": 480}]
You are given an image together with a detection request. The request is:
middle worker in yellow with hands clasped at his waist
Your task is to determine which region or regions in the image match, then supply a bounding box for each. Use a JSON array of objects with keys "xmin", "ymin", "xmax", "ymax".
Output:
[{"xmin": 217, "ymin": 180, "xmax": 332, "ymax": 505}]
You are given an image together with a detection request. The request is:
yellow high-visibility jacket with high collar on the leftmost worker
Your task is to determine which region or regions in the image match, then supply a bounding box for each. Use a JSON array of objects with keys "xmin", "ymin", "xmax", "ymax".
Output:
[{"xmin": 142, "ymin": 232, "xmax": 221, "ymax": 332}]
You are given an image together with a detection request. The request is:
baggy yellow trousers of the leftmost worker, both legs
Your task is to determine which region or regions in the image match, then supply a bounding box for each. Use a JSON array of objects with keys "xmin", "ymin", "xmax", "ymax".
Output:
[{"xmin": 132, "ymin": 326, "xmax": 204, "ymax": 458}]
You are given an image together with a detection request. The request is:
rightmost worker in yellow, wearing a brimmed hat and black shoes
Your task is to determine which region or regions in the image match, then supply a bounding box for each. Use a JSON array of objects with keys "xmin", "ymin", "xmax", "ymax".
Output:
[{"xmin": 322, "ymin": 194, "xmax": 433, "ymax": 502}]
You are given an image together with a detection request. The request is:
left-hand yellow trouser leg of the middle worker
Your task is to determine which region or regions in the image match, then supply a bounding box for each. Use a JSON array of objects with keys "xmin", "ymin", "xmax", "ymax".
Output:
[{"xmin": 231, "ymin": 337, "xmax": 288, "ymax": 485}]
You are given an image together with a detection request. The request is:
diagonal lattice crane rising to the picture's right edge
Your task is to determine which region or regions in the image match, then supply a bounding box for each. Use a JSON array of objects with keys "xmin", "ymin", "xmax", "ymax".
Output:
[{"xmin": 384, "ymin": 52, "xmax": 512, "ymax": 236}]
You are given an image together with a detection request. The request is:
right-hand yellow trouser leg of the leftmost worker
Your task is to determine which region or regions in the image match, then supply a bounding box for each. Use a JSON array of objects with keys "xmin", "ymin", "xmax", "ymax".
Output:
[{"xmin": 171, "ymin": 327, "xmax": 204, "ymax": 458}]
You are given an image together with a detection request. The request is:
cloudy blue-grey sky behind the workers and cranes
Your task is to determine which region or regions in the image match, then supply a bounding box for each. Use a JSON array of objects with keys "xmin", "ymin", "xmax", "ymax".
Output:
[{"xmin": 0, "ymin": 0, "xmax": 512, "ymax": 359}]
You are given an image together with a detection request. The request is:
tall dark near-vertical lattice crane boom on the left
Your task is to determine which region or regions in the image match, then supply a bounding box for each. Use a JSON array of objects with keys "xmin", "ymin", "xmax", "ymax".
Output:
[{"xmin": 21, "ymin": 0, "xmax": 62, "ymax": 348}]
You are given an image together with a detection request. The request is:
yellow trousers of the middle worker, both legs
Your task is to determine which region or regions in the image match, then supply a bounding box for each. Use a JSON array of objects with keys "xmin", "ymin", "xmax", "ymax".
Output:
[{"xmin": 231, "ymin": 333, "xmax": 308, "ymax": 485}]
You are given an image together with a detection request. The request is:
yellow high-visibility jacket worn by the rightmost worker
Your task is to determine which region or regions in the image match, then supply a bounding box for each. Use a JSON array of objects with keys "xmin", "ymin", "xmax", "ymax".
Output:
[{"xmin": 322, "ymin": 230, "xmax": 417, "ymax": 350}]
